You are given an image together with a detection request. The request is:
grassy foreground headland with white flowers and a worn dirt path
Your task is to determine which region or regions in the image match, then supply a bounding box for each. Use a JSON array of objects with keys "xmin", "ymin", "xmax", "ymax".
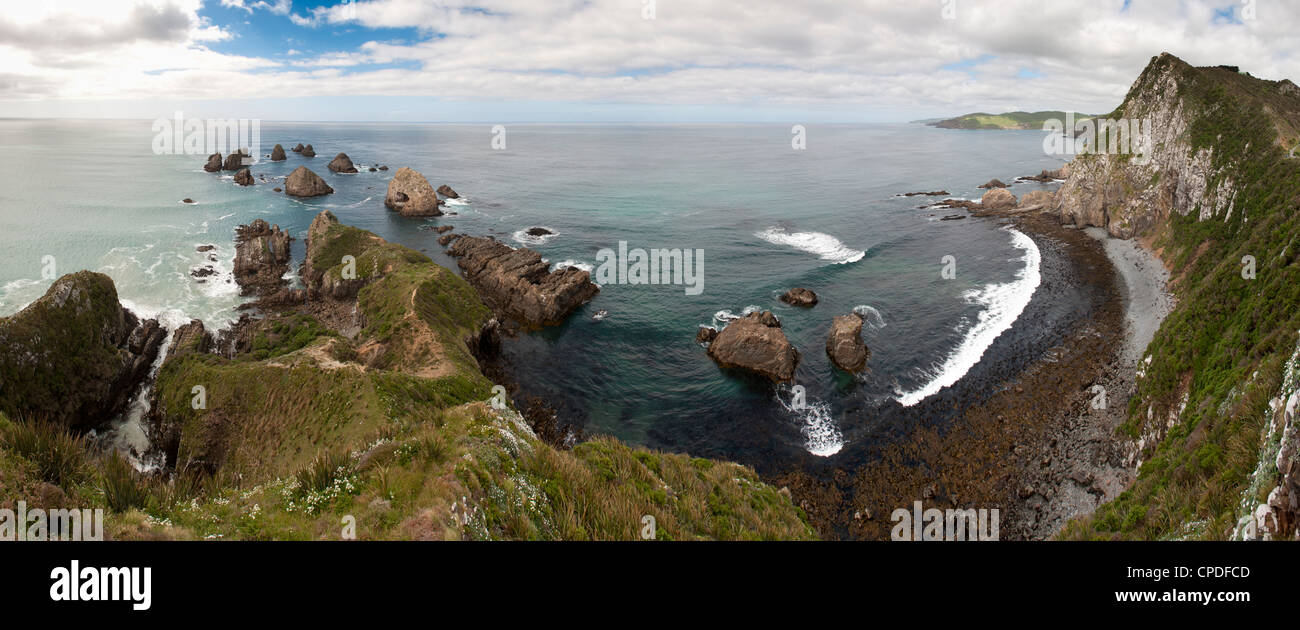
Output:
[{"xmin": 0, "ymin": 218, "xmax": 814, "ymax": 539}]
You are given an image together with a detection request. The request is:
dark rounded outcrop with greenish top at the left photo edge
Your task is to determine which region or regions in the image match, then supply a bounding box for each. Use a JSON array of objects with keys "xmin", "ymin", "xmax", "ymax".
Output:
[{"xmin": 0, "ymin": 271, "xmax": 166, "ymax": 430}]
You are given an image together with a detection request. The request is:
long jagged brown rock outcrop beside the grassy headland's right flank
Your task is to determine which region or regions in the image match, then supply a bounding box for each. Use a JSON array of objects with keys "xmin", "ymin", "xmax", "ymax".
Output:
[{"xmin": 441, "ymin": 235, "xmax": 599, "ymax": 326}]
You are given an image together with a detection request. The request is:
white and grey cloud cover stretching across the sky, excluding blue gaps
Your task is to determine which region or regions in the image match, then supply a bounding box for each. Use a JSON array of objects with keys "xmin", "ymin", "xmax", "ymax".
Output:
[{"xmin": 0, "ymin": 0, "xmax": 1300, "ymax": 117}]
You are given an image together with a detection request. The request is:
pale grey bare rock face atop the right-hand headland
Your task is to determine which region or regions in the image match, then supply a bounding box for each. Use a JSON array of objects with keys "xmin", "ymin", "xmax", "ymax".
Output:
[{"xmin": 1056, "ymin": 53, "xmax": 1300, "ymax": 238}]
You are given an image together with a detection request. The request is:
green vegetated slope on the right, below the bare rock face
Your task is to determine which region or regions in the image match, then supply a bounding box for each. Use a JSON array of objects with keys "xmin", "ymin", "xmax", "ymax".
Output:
[{"xmin": 1063, "ymin": 58, "xmax": 1300, "ymax": 539}]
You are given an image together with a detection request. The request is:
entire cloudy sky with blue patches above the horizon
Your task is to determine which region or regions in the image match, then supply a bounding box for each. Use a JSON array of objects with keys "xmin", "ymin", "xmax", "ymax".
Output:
[{"xmin": 0, "ymin": 0, "xmax": 1300, "ymax": 122}]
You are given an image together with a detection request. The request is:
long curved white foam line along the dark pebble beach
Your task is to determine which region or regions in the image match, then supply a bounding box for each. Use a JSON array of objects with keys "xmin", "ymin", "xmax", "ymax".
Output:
[{"xmin": 896, "ymin": 227, "xmax": 1043, "ymax": 407}]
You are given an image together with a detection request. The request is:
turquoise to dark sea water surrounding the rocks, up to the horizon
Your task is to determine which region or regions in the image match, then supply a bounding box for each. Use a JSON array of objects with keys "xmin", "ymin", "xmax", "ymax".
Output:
[{"xmin": 0, "ymin": 120, "xmax": 1060, "ymax": 465}]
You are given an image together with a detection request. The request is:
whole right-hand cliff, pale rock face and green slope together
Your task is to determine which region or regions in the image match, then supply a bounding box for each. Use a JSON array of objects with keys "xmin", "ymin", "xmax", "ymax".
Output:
[{"xmin": 1049, "ymin": 53, "xmax": 1300, "ymax": 539}]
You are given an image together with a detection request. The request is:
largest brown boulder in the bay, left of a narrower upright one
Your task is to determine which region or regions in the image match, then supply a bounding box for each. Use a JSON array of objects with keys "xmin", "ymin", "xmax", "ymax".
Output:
[{"xmin": 709, "ymin": 310, "xmax": 800, "ymax": 382}]
